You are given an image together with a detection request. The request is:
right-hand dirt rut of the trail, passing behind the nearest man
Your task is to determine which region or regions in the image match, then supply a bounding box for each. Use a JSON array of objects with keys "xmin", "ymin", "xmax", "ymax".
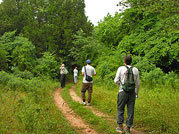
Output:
[{"xmin": 70, "ymin": 86, "xmax": 144, "ymax": 134}]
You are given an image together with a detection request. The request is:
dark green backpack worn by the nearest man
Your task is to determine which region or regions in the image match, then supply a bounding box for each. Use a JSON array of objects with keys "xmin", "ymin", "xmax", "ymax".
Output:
[{"xmin": 122, "ymin": 66, "xmax": 135, "ymax": 93}]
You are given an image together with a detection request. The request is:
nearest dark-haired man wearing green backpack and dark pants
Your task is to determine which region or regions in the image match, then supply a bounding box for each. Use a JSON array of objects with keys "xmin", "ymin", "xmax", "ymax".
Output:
[{"xmin": 114, "ymin": 55, "xmax": 140, "ymax": 134}]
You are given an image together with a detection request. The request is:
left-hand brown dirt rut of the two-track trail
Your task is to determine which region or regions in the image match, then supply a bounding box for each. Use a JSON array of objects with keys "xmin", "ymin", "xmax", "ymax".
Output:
[{"xmin": 54, "ymin": 88, "xmax": 98, "ymax": 134}]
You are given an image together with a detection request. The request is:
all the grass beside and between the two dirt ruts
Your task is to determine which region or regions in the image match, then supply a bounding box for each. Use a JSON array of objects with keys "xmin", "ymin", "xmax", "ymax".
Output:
[{"xmin": 0, "ymin": 74, "xmax": 179, "ymax": 134}]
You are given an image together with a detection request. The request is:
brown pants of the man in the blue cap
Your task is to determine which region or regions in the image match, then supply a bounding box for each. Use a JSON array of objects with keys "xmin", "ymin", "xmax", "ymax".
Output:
[{"xmin": 81, "ymin": 83, "xmax": 93, "ymax": 103}]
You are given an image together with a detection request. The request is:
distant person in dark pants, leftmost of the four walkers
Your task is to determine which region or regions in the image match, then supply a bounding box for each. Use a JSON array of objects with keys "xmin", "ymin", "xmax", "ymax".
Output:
[{"xmin": 60, "ymin": 64, "xmax": 68, "ymax": 88}]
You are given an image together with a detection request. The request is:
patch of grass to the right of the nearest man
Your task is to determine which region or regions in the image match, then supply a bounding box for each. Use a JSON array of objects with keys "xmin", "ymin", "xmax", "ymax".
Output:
[{"xmin": 135, "ymin": 86, "xmax": 179, "ymax": 134}]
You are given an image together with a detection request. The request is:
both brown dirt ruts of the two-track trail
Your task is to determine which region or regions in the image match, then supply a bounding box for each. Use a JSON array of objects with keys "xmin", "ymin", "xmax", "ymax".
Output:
[{"xmin": 54, "ymin": 86, "xmax": 143, "ymax": 134}]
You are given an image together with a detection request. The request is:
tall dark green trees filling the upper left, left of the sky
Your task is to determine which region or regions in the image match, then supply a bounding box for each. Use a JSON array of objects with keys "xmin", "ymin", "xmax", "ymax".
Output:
[{"xmin": 0, "ymin": 0, "xmax": 93, "ymax": 66}]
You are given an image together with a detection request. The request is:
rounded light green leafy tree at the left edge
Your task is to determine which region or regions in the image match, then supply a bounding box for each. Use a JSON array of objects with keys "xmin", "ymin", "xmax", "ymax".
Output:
[{"xmin": 0, "ymin": 31, "xmax": 36, "ymax": 71}]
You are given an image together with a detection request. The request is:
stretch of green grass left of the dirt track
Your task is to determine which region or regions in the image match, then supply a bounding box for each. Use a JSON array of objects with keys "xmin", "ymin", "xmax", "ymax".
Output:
[{"xmin": 0, "ymin": 81, "xmax": 76, "ymax": 134}]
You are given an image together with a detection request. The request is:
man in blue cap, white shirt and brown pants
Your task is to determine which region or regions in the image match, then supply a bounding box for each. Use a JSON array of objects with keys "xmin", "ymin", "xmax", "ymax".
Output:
[{"xmin": 81, "ymin": 59, "xmax": 96, "ymax": 106}]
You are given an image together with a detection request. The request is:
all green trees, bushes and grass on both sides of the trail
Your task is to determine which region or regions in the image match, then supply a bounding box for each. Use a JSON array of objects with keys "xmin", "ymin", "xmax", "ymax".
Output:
[{"xmin": 0, "ymin": 0, "xmax": 179, "ymax": 134}]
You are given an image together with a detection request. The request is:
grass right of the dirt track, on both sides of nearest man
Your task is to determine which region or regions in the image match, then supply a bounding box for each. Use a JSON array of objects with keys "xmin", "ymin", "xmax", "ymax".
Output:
[{"xmin": 73, "ymin": 78, "xmax": 179, "ymax": 134}]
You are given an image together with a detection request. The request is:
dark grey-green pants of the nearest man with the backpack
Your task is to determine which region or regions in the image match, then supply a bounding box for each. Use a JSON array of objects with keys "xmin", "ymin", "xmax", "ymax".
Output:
[{"xmin": 117, "ymin": 91, "xmax": 135, "ymax": 127}]
